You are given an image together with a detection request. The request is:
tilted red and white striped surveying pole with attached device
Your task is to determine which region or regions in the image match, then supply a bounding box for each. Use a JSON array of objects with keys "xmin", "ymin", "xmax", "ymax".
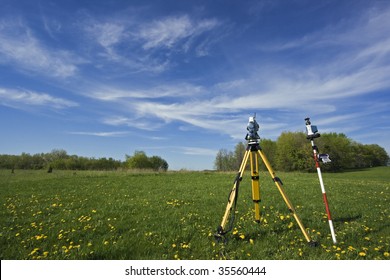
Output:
[{"xmin": 305, "ymin": 118, "xmax": 337, "ymax": 244}]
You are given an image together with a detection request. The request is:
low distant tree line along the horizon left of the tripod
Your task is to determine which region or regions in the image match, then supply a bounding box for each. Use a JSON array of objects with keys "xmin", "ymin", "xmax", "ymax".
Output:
[{"xmin": 0, "ymin": 149, "xmax": 168, "ymax": 171}]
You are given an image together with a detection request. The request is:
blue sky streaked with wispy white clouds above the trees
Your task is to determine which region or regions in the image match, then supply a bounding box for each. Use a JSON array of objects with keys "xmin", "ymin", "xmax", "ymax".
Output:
[{"xmin": 0, "ymin": 0, "xmax": 390, "ymax": 170}]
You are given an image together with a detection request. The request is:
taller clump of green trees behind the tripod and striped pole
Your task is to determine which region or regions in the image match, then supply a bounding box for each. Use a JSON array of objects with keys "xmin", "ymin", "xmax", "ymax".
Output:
[{"xmin": 214, "ymin": 132, "xmax": 389, "ymax": 172}]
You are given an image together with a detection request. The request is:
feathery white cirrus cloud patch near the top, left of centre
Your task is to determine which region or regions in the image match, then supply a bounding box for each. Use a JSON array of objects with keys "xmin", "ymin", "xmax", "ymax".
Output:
[{"xmin": 82, "ymin": 14, "xmax": 221, "ymax": 73}]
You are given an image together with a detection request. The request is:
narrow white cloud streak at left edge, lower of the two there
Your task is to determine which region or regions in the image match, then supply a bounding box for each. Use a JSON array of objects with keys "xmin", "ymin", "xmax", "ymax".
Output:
[{"xmin": 0, "ymin": 88, "xmax": 78, "ymax": 109}]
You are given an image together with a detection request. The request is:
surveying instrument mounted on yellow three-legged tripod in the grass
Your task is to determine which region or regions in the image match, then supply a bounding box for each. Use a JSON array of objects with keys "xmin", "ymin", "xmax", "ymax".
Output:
[{"xmin": 214, "ymin": 114, "xmax": 318, "ymax": 247}]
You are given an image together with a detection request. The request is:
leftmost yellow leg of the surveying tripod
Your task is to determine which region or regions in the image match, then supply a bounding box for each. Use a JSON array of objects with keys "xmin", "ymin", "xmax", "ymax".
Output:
[{"xmin": 214, "ymin": 150, "xmax": 250, "ymax": 239}]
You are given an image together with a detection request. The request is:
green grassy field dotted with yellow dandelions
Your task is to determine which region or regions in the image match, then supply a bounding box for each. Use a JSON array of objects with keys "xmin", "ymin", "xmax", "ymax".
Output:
[{"xmin": 0, "ymin": 167, "xmax": 390, "ymax": 260}]
